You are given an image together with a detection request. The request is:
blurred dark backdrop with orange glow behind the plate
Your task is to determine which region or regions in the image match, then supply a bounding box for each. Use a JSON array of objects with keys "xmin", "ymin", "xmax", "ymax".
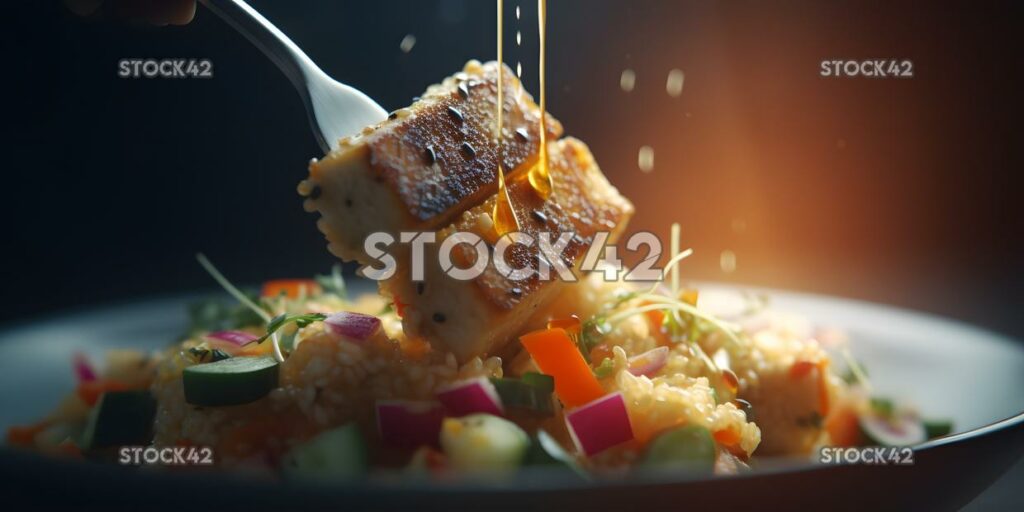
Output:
[{"xmin": 0, "ymin": 0, "xmax": 1024, "ymax": 344}]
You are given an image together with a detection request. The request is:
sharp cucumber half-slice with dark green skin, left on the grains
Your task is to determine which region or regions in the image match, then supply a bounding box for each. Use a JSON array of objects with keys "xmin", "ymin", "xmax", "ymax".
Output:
[{"xmin": 182, "ymin": 357, "xmax": 280, "ymax": 407}]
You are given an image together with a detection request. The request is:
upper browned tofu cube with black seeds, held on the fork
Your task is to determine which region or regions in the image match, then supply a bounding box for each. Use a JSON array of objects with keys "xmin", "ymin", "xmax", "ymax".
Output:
[{"xmin": 299, "ymin": 60, "xmax": 562, "ymax": 263}]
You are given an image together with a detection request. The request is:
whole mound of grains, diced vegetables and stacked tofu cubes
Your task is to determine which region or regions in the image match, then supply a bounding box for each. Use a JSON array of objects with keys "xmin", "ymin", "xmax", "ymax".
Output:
[{"xmin": 7, "ymin": 61, "xmax": 950, "ymax": 481}]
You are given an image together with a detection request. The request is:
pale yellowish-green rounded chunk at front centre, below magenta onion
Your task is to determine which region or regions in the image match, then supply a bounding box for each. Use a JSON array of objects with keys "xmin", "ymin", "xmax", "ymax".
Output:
[{"xmin": 441, "ymin": 414, "xmax": 529, "ymax": 473}]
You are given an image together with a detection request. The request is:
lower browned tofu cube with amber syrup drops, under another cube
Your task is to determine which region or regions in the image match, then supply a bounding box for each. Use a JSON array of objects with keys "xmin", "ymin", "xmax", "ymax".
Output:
[{"xmin": 381, "ymin": 138, "xmax": 633, "ymax": 360}]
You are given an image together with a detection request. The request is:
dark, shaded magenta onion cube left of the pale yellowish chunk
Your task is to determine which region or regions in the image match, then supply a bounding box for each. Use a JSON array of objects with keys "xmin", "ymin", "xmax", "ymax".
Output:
[{"xmin": 377, "ymin": 400, "xmax": 444, "ymax": 449}]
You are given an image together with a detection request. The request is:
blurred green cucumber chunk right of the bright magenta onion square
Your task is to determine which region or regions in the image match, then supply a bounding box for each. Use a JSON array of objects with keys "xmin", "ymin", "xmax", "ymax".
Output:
[{"xmin": 641, "ymin": 425, "xmax": 718, "ymax": 474}]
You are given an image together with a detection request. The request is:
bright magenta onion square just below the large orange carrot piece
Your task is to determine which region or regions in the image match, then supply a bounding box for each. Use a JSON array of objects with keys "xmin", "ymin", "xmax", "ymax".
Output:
[{"xmin": 565, "ymin": 392, "xmax": 633, "ymax": 457}]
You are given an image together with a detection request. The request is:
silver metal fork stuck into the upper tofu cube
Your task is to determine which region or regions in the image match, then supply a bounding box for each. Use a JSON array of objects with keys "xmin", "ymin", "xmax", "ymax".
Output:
[{"xmin": 200, "ymin": 0, "xmax": 387, "ymax": 153}]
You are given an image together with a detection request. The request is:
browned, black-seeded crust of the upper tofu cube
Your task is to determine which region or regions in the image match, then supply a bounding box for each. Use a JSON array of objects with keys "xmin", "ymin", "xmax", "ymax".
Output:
[{"xmin": 309, "ymin": 61, "xmax": 562, "ymax": 228}]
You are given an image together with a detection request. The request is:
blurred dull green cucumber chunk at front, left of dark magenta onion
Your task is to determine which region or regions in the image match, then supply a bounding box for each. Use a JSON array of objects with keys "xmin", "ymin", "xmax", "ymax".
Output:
[{"xmin": 282, "ymin": 423, "xmax": 368, "ymax": 480}]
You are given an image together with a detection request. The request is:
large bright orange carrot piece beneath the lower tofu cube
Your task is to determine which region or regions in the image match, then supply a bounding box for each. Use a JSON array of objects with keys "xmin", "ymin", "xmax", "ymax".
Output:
[{"xmin": 519, "ymin": 329, "xmax": 604, "ymax": 408}]
